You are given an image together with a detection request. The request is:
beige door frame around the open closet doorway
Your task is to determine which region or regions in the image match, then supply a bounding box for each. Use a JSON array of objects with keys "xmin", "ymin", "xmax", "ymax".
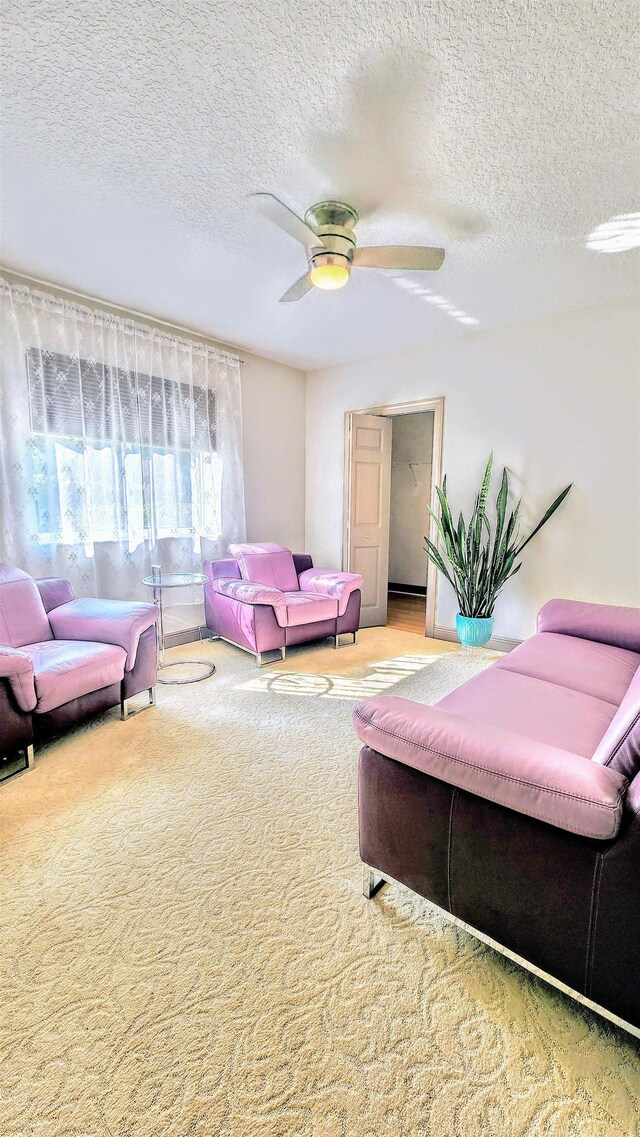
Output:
[{"xmin": 342, "ymin": 396, "xmax": 444, "ymax": 639}]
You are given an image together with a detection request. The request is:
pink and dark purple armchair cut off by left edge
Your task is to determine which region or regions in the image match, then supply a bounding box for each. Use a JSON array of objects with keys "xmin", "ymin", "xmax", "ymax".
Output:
[{"xmin": 0, "ymin": 564, "xmax": 158, "ymax": 777}]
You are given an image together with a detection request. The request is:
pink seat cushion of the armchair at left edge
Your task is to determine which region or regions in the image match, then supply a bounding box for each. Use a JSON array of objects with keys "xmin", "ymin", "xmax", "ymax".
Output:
[{"xmin": 23, "ymin": 640, "xmax": 126, "ymax": 714}]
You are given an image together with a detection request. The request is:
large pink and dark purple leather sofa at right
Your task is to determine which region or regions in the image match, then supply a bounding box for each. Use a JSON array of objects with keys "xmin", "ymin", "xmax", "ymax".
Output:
[{"xmin": 354, "ymin": 600, "xmax": 640, "ymax": 1037}]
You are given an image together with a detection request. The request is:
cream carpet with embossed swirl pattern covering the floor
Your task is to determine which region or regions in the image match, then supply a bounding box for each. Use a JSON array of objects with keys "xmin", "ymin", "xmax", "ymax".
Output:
[{"xmin": 0, "ymin": 630, "xmax": 640, "ymax": 1137}]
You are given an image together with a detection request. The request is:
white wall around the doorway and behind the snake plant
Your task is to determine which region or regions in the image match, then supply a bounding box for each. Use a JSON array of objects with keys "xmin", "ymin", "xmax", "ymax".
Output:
[{"xmin": 307, "ymin": 300, "xmax": 640, "ymax": 639}]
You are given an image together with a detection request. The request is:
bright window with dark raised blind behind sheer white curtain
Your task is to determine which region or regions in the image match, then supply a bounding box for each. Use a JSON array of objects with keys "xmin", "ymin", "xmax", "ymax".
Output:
[{"xmin": 26, "ymin": 348, "xmax": 222, "ymax": 548}]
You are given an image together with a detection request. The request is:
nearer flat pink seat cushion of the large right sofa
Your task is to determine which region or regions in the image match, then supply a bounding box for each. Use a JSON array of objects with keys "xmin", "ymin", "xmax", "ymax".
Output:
[{"xmin": 438, "ymin": 665, "xmax": 617, "ymax": 758}]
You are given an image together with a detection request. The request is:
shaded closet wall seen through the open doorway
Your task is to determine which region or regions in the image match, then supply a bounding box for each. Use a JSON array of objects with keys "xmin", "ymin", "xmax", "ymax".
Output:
[{"xmin": 389, "ymin": 410, "xmax": 433, "ymax": 588}]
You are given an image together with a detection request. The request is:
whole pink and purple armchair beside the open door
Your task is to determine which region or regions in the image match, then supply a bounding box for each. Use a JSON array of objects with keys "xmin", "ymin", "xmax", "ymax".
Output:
[{"xmin": 205, "ymin": 543, "xmax": 363, "ymax": 666}]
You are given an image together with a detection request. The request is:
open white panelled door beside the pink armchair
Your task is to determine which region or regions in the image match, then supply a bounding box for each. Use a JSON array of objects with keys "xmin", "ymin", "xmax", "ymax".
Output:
[{"xmin": 347, "ymin": 415, "xmax": 391, "ymax": 628}]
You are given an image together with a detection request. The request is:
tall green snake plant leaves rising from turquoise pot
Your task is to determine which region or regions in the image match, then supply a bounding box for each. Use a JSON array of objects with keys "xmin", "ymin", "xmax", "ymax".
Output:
[{"xmin": 424, "ymin": 454, "xmax": 571, "ymax": 619}]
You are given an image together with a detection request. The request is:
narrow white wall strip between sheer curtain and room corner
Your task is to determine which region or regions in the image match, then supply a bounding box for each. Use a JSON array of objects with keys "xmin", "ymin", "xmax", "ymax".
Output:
[{"xmin": 240, "ymin": 354, "xmax": 305, "ymax": 553}]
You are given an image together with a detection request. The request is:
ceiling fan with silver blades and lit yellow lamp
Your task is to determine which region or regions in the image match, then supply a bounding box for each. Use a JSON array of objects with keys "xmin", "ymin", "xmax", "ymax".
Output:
[{"xmin": 251, "ymin": 193, "xmax": 444, "ymax": 304}]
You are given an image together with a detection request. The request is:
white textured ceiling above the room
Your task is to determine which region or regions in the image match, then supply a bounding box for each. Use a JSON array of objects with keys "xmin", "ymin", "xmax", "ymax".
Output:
[{"xmin": 2, "ymin": 0, "xmax": 640, "ymax": 368}]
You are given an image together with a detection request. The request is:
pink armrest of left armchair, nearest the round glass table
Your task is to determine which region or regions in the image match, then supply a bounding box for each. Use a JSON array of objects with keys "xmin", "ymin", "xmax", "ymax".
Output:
[{"xmin": 49, "ymin": 597, "xmax": 158, "ymax": 671}]
